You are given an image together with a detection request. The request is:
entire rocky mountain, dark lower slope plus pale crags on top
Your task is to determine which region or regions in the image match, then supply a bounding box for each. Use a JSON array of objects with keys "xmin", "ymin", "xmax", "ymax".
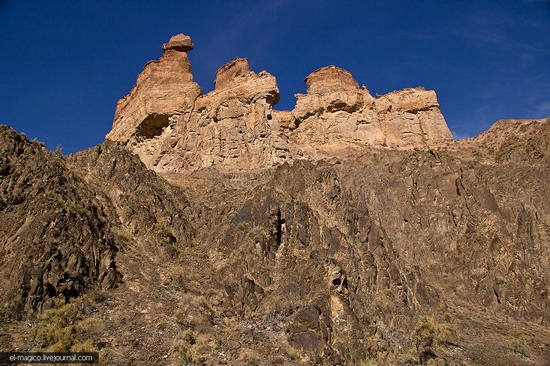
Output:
[{"xmin": 0, "ymin": 36, "xmax": 550, "ymax": 365}]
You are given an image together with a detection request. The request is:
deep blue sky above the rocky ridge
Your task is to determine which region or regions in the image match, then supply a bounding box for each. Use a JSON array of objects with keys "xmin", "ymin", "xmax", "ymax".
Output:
[{"xmin": 0, "ymin": 0, "xmax": 550, "ymax": 153}]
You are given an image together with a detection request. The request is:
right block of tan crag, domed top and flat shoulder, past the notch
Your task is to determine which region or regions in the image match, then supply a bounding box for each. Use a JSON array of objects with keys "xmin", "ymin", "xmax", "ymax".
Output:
[{"xmin": 290, "ymin": 66, "xmax": 452, "ymax": 148}]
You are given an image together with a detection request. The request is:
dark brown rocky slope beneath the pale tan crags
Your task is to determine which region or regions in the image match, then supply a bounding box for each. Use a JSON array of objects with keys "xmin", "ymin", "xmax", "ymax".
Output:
[{"xmin": 0, "ymin": 118, "xmax": 550, "ymax": 365}]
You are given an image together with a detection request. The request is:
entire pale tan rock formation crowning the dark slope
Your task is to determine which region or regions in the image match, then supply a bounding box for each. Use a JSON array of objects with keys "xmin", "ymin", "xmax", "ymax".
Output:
[{"xmin": 107, "ymin": 34, "xmax": 452, "ymax": 172}]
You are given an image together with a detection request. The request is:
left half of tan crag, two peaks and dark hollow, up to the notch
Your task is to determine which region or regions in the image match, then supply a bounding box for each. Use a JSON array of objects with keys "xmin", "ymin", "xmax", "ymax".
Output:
[{"xmin": 107, "ymin": 34, "xmax": 298, "ymax": 172}]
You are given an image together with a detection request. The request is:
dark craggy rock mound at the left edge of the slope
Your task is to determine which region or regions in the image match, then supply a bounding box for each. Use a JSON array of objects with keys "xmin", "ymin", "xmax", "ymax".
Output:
[{"xmin": 0, "ymin": 126, "xmax": 121, "ymax": 318}]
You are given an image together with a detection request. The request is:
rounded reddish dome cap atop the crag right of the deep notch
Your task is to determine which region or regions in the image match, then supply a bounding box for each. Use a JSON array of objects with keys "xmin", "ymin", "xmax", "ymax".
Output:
[{"xmin": 304, "ymin": 65, "xmax": 359, "ymax": 93}]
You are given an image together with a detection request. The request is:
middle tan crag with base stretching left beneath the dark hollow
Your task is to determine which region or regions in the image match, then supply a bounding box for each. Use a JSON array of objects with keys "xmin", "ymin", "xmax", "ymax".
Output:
[{"xmin": 134, "ymin": 58, "xmax": 290, "ymax": 172}]
